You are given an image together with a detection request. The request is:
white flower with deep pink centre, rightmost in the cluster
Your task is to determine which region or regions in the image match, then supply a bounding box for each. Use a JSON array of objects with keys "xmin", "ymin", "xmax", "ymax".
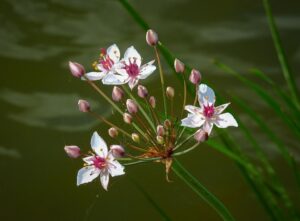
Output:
[{"xmin": 181, "ymin": 84, "xmax": 238, "ymax": 134}]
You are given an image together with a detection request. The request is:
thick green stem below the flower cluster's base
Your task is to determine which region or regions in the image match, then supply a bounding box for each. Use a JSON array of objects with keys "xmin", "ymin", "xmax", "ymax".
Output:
[{"xmin": 172, "ymin": 159, "xmax": 235, "ymax": 221}]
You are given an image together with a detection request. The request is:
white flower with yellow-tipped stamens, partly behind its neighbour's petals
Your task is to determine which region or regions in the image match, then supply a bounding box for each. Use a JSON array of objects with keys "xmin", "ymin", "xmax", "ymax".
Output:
[{"xmin": 82, "ymin": 44, "xmax": 120, "ymax": 81}]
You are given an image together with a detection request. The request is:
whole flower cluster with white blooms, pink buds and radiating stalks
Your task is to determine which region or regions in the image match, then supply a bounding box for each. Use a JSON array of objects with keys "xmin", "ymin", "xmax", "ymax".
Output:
[{"xmin": 65, "ymin": 30, "xmax": 238, "ymax": 190}]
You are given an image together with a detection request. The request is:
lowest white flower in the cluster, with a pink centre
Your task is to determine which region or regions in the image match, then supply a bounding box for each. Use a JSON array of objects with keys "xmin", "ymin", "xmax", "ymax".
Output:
[{"xmin": 77, "ymin": 132, "xmax": 125, "ymax": 190}]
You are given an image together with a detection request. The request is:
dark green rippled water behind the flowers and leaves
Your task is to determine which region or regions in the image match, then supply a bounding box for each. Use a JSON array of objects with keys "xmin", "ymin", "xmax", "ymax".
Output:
[{"xmin": 0, "ymin": 0, "xmax": 300, "ymax": 221}]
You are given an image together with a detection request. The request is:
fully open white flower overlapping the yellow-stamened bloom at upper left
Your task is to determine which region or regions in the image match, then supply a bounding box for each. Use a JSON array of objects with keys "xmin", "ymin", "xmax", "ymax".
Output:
[{"xmin": 102, "ymin": 46, "xmax": 156, "ymax": 89}]
